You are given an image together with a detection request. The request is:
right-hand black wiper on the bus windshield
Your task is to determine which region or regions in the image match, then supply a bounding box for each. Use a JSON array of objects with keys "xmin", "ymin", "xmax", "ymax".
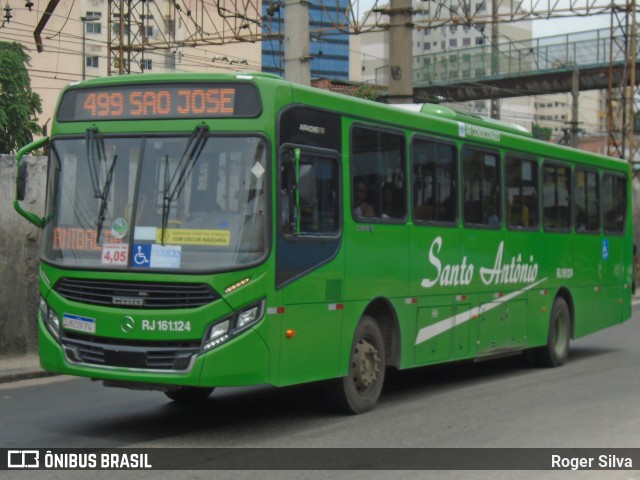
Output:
[{"xmin": 160, "ymin": 125, "xmax": 209, "ymax": 245}]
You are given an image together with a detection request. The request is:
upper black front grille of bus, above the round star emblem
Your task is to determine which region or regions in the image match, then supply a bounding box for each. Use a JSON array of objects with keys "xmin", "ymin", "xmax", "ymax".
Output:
[{"xmin": 54, "ymin": 278, "xmax": 222, "ymax": 309}]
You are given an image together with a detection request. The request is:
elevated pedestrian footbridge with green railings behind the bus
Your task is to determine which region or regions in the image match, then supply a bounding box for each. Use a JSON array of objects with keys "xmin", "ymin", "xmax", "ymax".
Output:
[{"xmin": 376, "ymin": 28, "xmax": 640, "ymax": 102}]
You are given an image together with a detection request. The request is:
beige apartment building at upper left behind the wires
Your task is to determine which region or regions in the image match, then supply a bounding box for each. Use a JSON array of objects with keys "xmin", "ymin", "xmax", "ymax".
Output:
[{"xmin": 0, "ymin": 0, "xmax": 262, "ymax": 129}]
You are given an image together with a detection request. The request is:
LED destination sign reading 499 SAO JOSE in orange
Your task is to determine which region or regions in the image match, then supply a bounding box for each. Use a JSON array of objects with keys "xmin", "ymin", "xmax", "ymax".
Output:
[{"xmin": 58, "ymin": 83, "xmax": 261, "ymax": 122}]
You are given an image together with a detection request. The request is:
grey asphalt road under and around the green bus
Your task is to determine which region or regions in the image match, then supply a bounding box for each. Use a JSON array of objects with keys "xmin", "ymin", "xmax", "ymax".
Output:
[{"xmin": 0, "ymin": 306, "xmax": 640, "ymax": 480}]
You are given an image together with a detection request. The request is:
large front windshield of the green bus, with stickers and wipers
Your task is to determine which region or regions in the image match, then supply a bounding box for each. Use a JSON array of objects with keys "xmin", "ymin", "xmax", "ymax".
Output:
[{"xmin": 43, "ymin": 133, "xmax": 268, "ymax": 271}]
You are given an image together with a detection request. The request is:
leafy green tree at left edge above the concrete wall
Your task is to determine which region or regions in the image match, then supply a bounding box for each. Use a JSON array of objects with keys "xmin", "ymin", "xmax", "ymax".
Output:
[{"xmin": 0, "ymin": 42, "xmax": 42, "ymax": 153}]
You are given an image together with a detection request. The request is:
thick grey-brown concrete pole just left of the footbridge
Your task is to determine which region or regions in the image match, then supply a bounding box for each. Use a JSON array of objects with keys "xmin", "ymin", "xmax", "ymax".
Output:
[{"xmin": 388, "ymin": 0, "xmax": 413, "ymax": 103}]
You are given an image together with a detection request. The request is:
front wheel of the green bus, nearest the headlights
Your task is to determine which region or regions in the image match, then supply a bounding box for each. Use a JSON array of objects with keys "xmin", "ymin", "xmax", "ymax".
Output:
[{"xmin": 334, "ymin": 315, "xmax": 385, "ymax": 414}]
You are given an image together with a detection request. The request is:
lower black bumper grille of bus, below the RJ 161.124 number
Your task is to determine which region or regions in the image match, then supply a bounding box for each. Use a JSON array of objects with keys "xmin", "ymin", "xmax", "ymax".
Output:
[{"xmin": 62, "ymin": 334, "xmax": 200, "ymax": 371}]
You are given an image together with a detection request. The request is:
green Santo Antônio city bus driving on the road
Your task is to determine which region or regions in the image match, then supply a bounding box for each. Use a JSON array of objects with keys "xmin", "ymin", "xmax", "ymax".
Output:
[{"xmin": 15, "ymin": 73, "xmax": 633, "ymax": 413}]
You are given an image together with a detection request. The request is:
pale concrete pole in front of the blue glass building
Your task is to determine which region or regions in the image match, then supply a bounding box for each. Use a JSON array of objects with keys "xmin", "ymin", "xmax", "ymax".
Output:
[{"xmin": 284, "ymin": 0, "xmax": 311, "ymax": 85}]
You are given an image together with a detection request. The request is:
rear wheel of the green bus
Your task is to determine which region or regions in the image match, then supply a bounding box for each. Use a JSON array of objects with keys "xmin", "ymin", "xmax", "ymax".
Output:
[{"xmin": 531, "ymin": 297, "xmax": 571, "ymax": 368}]
